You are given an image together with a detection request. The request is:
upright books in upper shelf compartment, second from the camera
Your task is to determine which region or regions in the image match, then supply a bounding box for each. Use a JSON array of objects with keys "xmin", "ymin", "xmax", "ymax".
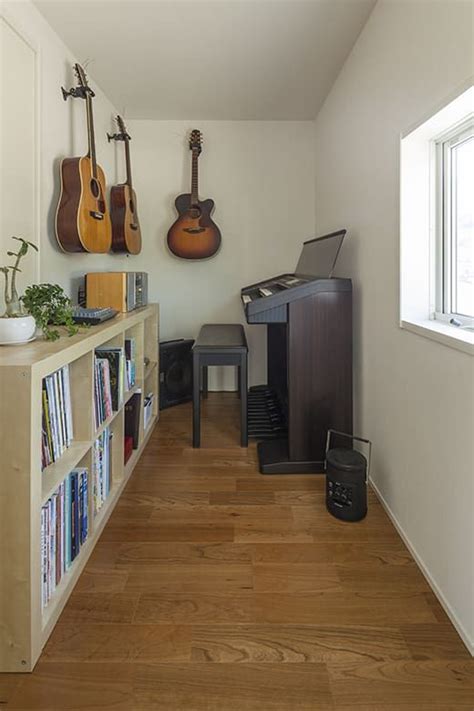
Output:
[{"xmin": 94, "ymin": 347, "xmax": 125, "ymax": 427}]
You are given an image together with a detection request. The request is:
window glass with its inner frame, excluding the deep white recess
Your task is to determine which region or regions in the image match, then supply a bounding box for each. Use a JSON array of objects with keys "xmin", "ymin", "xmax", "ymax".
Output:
[{"xmin": 435, "ymin": 117, "xmax": 474, "ymax": 328}]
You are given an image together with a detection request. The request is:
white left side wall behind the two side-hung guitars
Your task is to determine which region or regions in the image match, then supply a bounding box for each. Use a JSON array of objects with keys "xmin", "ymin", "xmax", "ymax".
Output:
[{"xmin": 0, "ymin": 2, "xmax": 122, "ymax": 296}]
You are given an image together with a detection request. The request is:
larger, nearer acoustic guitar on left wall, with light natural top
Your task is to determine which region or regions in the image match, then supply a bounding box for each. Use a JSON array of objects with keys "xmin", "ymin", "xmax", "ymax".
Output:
[{"xmin": 56, "ymin": 64, "xmax": 112, "ymax": 253}]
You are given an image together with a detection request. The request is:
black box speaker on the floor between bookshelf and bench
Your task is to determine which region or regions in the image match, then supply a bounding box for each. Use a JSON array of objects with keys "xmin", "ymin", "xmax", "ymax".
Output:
[{"xmin": 160, "ymin": 338, "xmax": 194, "ymax": 410}]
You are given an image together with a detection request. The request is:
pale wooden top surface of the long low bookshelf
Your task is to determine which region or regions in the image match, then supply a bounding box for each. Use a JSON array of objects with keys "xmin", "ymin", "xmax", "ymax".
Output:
[{"xmin": 0, "ymin": 304, "xmax": 158, "ymax": 368}]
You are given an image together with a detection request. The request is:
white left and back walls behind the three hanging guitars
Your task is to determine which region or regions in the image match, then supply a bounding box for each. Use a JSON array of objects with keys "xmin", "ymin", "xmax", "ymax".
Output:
[{"xmin": 2, "ymin": 2, "xmax": 315, "ymax": 388}]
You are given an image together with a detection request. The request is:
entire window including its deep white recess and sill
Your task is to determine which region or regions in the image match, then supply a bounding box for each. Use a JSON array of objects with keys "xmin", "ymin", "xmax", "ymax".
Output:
[{"xmin": 400, "ymin": 81, "xmax": 474, "ymax": 356}]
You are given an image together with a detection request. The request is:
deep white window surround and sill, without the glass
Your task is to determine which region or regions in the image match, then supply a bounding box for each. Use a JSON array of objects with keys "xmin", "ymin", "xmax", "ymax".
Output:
[{"xmin": 399, "ymin": 83, "xmax": 474, "ymax": 357}]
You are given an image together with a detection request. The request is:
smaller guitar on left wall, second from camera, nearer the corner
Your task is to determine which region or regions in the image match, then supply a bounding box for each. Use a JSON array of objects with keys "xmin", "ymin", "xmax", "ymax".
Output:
[{"xmin": 107, "ymin": 116, "xmax": 142, "ymax": 254}]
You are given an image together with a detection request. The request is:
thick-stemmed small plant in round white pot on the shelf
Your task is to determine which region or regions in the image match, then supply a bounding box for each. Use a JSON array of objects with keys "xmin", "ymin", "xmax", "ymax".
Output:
[{"xmin": 0, "ymin": 237, "xmax": 38, "ymax": 345}]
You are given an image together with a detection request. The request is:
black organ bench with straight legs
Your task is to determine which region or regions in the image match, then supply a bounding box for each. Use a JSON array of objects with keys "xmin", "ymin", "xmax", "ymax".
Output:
[{"xmin": 193, "ymin": 323, "xmax": 248, "ymax": 447}]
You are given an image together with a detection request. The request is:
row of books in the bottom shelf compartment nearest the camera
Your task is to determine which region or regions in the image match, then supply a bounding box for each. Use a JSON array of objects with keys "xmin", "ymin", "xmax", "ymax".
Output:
[{"xmin": 41, "ymin": 469, "xmax": 89, "ymax": 608}]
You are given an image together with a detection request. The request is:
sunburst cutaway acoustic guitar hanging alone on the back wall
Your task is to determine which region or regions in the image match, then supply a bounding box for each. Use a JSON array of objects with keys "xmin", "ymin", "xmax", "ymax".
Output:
[{"xmin": 168, "ymin": 129, "xmax": 221, "ymax": 259}]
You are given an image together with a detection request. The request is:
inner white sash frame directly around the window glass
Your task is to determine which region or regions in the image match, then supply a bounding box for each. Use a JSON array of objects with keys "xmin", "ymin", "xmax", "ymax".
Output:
[{"xmin": 432, "ymin": 113, "xmax": 474, "ymax": 330}]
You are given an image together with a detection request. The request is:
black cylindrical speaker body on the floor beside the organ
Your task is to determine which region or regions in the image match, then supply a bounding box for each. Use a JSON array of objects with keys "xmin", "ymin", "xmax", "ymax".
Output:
[{"xmin": 326, "ymin": 449, "xmax": 367, "ymax": 521}]
